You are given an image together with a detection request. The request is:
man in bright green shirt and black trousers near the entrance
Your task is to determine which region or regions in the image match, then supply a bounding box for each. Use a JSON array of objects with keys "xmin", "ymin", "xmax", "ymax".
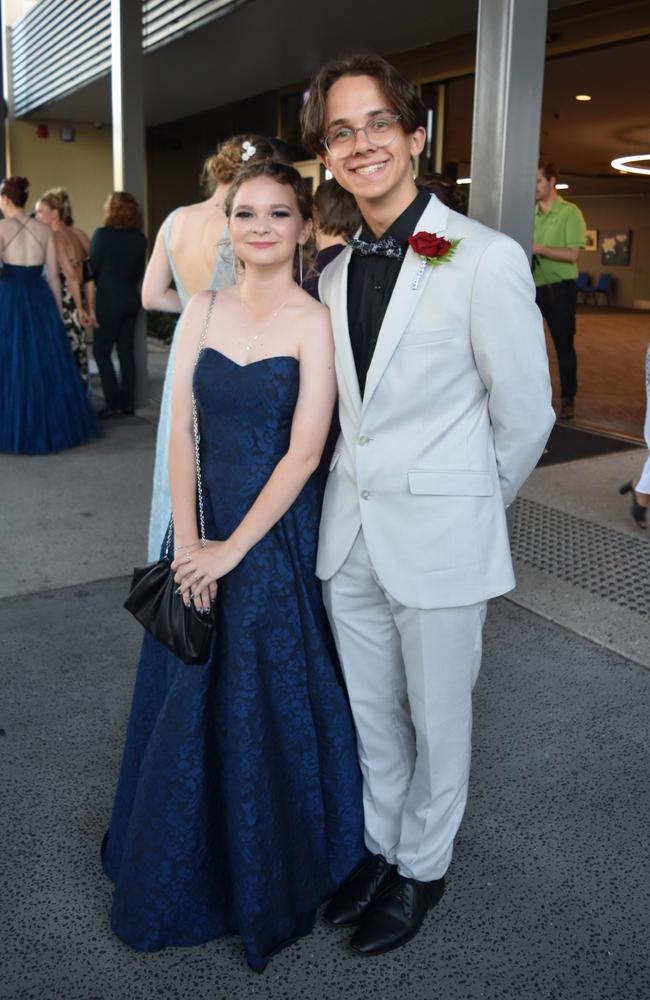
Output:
[{"xmin": 533, "ymin": 160, "xmax": 587, "ymax": 420}]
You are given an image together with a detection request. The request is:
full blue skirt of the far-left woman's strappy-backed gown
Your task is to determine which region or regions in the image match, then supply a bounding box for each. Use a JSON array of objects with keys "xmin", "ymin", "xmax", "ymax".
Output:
[{"xmin": 0, "ymin": 264, "xmax": 99, "ymax": 455}]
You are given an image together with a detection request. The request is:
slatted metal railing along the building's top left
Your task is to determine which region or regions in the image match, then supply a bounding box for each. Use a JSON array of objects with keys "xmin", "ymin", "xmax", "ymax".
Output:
[{"xmin": 9, "ymin": 0, "xmax": 248, "ymax": 117}]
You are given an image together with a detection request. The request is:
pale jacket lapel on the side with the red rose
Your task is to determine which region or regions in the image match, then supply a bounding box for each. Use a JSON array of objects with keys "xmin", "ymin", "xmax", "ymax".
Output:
[{"xmin": 362, "ymin": 196, "xmax": 449, "ymax": 413}]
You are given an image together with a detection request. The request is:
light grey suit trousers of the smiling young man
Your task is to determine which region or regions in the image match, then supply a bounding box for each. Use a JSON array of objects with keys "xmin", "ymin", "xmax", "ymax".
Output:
[{"xmin": 323, "ymin": 530, "xmax": 486, "ymax": 882}]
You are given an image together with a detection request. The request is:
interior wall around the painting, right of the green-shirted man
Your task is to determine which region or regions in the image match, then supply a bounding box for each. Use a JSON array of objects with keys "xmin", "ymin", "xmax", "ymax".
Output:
[{"xmin": 568, "ymin": 194, "xmax": 650, "ymax": 309}]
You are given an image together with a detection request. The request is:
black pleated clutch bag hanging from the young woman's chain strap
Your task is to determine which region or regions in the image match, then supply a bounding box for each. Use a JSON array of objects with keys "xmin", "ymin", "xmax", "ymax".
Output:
[{"xmin": 124, "ymin": 559, "xmax": 215, "ymax": 664}]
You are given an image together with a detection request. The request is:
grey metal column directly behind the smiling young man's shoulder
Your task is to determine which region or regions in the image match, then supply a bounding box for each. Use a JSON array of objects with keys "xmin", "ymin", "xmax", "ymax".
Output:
[{"xmin": 469, "ymin": 0, "xmax": 548, "ymax": 256}]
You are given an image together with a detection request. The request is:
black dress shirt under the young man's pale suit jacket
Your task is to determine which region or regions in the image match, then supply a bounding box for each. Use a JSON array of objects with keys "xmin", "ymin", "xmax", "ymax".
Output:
[{"xmin": 348, "ymin": 189, "xmax": 430, "ymax": 397}]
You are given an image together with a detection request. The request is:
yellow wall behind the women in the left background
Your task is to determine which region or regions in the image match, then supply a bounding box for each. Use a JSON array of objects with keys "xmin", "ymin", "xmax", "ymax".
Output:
[{"xmin": 7, "ymin": 119, "xmax": 113, "ymax": 235}]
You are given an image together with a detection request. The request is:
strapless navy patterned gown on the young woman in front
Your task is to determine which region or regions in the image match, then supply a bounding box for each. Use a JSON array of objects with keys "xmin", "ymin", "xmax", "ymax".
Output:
[{"xmin": 103, "ymin": 348, "xmax": 365, "ymax": 970}]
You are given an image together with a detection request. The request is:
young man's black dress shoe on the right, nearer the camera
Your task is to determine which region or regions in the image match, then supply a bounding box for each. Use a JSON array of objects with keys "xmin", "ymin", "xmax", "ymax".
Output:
[{"xmin": 350, "ymin": 875, "xmax": 445, "ymax": 955}]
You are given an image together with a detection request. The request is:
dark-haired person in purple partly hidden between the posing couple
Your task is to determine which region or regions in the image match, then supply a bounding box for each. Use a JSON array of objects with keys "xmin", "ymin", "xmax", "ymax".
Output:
[{"xmin": 302, "ymin": 178, "xmax": 361, "ymax": 298}]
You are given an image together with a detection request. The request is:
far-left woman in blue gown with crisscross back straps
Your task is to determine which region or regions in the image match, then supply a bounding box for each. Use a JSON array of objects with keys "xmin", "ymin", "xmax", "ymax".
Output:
[{"xmin": 0, "ymin": 177, "xmax": 99, "ymax": 455}]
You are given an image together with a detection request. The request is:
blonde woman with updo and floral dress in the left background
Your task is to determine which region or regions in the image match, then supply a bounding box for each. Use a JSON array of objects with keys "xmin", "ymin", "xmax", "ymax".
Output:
[{"xmin": 36, "ymin": 188, "xmax": 91, "ymax": 383}]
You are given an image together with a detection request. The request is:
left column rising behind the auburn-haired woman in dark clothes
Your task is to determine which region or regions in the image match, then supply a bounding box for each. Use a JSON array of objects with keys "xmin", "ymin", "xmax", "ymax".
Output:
[{"xmin": 111, "ymin": 0, "xmax": 149, "ymax": 406}]
